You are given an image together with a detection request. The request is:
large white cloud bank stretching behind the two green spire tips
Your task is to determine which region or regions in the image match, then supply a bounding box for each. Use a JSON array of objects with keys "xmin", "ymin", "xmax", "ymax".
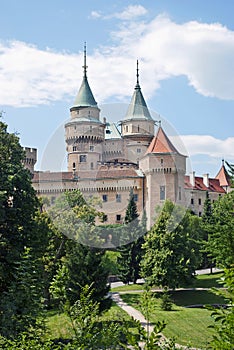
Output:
[{"xmin": 0, "ymin": 12, "xmax": 234, "ymax": 106}]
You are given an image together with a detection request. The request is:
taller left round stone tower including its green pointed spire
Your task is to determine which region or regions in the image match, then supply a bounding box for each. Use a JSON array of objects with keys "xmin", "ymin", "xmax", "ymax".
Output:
[{"xmin": 65, "ymin": 45, "xmax": 105, "ymax": 174}]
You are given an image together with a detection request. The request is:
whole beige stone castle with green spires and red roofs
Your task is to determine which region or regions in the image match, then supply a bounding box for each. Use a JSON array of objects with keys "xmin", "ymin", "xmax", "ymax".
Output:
[{"xmin": 22, "ymin": 49, "xmax": 231, "ymax": 228}]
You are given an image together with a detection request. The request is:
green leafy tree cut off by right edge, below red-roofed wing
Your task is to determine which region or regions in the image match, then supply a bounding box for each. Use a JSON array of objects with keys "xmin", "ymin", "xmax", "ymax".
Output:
[{"xmin": 207, "ymin": 191, "xmax": 234, "ymax": 268}]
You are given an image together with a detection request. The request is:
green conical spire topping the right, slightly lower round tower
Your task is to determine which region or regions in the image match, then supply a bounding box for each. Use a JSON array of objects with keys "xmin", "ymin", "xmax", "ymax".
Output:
[{"xmin": 124, "ymin": 60, "xmax": 152, "ymax": 120}]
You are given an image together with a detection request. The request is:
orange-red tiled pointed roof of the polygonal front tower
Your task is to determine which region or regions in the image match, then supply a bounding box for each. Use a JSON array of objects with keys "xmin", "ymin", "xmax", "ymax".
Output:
[{"xmin": 146, "ymin": 127, "xmax": 178, "ymax": 153}]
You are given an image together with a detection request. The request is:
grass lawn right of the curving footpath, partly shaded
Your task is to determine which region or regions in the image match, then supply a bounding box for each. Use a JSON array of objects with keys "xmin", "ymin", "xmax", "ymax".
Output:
[{"xmin": 121, "ymin": 291, "xmax": 224, "ymax": 349}]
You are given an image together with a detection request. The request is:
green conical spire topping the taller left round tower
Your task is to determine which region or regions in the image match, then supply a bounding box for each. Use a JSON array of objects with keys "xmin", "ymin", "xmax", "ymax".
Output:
[{"xmin": 73, "ymin": 43, "xmax": 97, "ymax": 107}]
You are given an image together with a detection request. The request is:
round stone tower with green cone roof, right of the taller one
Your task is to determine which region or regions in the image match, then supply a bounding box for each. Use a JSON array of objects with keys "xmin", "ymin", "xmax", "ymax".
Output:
[{"xmin": 120, "ymin": 61, "xmax": 155, "ymax": 163}]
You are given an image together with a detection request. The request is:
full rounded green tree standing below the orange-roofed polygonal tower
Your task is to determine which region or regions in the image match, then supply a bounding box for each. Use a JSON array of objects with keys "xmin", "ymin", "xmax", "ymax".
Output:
[{"xmin": 141, "ymin": 201, "xmax": 200, "ymax": 290}]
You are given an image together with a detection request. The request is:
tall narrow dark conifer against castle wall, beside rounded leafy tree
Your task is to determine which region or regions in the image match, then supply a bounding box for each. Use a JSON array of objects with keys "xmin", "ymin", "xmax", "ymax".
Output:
[{"xmin": 117, "ymin": 190, "xmax": 143, "ymax": 283}]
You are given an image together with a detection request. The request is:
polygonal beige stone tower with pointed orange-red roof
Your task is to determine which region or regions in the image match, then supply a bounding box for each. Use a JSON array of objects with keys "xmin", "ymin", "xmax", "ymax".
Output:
[{"xmin": 139, "ymin": 125, "xmax": 186, "ymax": 228}]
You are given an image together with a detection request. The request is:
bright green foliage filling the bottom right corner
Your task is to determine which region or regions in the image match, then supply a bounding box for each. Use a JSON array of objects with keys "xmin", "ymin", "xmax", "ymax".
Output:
[{"xmin": 209, "ymin": 267, "xmax": 234, "ymax": 350}]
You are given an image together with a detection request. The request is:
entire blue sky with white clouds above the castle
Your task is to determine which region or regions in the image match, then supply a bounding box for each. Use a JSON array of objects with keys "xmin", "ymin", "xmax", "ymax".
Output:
[{"xmin": 0, "ymin": 0, "xmax": 234, "ymax": 177}]
